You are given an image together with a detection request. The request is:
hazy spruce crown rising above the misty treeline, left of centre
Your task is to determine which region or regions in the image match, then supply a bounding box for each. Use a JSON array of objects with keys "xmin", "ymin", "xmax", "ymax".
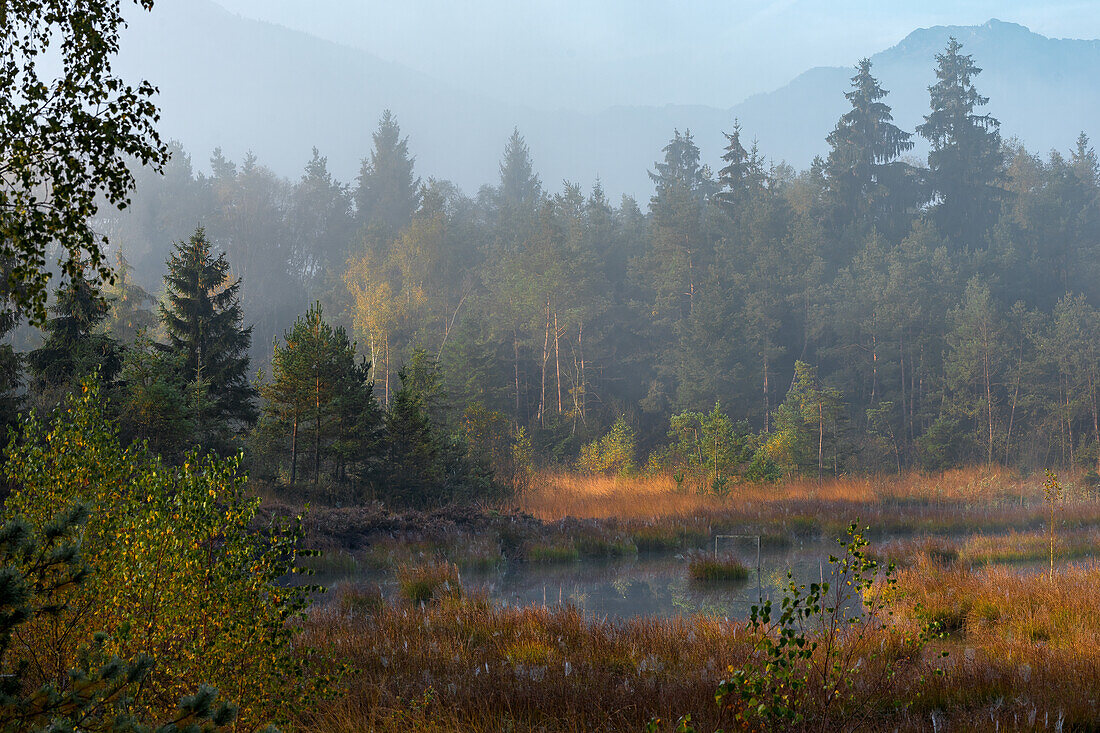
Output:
[{"xmin": 355, "ymin": 109, "xmax": 420, "ymax": 237}]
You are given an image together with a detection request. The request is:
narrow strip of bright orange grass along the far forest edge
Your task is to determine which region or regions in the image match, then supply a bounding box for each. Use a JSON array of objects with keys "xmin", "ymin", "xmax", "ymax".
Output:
[{"xmin": 518, "ymin": 468, "xmax": 1084, "ymax": 522}]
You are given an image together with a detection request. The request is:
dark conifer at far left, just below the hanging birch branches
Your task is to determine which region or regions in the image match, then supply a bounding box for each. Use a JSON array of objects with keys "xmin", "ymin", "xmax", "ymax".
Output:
[{"xmin": 26, "ymin": 267, "xmax": 122, "ymax": 401}]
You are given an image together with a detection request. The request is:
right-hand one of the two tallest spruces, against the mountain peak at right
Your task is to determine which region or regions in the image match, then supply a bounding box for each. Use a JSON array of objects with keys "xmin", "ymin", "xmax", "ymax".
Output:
[{"xmin": 916, "ymin": 37, "xmax": 1004, "ymax": 249}]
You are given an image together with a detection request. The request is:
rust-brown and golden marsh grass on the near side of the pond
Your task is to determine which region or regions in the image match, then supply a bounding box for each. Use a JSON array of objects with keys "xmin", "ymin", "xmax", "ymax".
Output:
[{"xmin": 298, "ymin": 556, "xmax": 1100, "ymax": 733}]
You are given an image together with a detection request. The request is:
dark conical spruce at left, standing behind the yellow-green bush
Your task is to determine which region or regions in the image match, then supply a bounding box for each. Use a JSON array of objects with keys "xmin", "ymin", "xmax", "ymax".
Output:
[{"xmin": 161, "ymin": 227, "xmax": 256, "ymax": 441}]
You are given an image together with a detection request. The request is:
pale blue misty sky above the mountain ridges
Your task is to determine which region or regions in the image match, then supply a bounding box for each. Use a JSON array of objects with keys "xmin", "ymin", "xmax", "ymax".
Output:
[{"xmin": 206, "ymin": 0, "xmax": 1100, "ymax": 110}]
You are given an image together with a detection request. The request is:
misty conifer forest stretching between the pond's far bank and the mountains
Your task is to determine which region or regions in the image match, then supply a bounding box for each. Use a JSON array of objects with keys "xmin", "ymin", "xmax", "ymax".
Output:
[{"xmin": 6, "ymin": 41, "xmax": 1100, "ymax": 493}]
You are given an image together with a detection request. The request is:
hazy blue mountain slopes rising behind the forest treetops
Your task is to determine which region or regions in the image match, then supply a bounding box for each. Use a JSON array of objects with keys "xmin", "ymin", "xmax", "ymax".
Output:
[{"xmin": 118, "ymin": 0, "xmax": 1100, "ymax": 199}]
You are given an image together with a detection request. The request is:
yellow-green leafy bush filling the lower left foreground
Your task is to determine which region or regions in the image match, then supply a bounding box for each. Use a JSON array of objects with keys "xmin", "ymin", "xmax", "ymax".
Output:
[{"xmin": 4, "ymin": 384, "xmax": 321, "ymax": 731}]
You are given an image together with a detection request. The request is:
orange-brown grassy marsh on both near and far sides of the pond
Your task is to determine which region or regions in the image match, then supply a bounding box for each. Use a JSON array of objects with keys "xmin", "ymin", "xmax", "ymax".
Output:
[{"xmin": 277, "ymin": 470, "xmax": 1100, "ymax": 733}]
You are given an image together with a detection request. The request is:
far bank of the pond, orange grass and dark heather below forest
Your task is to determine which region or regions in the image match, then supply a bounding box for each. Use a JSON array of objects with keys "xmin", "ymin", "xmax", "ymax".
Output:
[{"xmin": 266, "ymin": 469, "xmax": 1100, "ymax": 575}]
